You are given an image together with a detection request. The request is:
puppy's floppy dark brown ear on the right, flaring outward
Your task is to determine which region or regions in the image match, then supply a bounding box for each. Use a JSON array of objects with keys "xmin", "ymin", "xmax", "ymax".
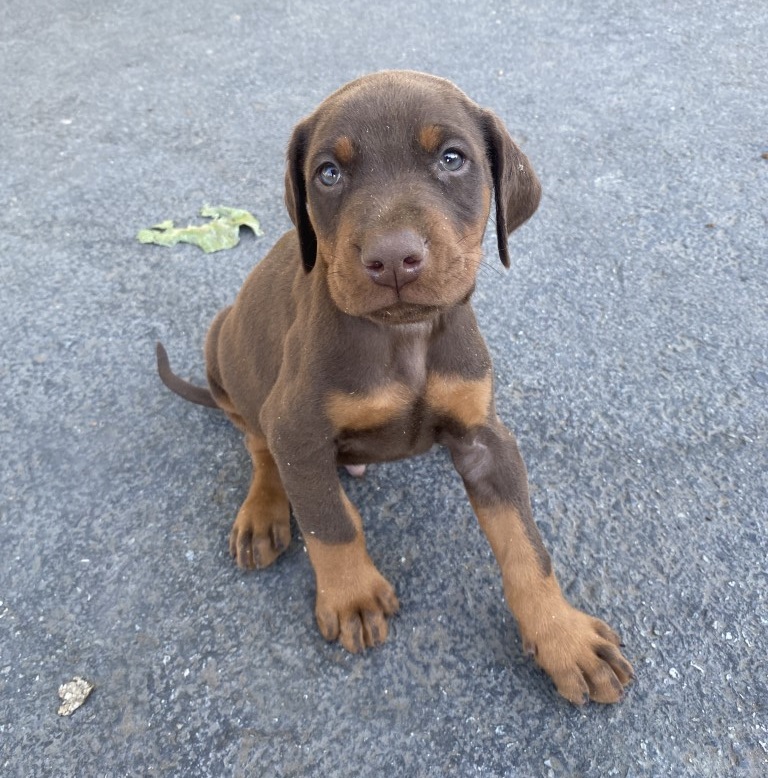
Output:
[{"xmin": 482, "ymin": 111, "xmax": 541, "ymax": 267}]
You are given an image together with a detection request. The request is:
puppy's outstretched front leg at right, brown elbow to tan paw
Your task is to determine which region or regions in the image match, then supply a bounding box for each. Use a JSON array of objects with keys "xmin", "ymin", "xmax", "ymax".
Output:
[{"xmin": 448, "ymin": 418, "xmax": 632, "ymax": 705}]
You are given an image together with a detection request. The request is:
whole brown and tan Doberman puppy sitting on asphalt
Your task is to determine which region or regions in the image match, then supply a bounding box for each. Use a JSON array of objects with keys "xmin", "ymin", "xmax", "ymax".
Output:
[{"xmin": 158, "ymin": 71, "xmax": 632, "ymax": 704}]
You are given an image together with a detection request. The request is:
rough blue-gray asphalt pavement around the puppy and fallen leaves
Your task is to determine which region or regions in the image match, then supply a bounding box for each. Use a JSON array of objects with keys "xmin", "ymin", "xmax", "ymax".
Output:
[{"xmin": 0, "ymin": 0, "xmax": 768, "ymax": 777}]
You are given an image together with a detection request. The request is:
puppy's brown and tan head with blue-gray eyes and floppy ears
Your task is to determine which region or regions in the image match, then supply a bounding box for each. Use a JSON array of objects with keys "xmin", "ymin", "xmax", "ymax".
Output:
[{"xmin": 285, "ymin": 71, "xmax": 541, "ymax": 323}]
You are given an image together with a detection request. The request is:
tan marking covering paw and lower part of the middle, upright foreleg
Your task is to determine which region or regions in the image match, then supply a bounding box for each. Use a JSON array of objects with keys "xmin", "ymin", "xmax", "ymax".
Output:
[{"xmin": 304, "ymin": 489, "xmax": 399, "ymax": 654}]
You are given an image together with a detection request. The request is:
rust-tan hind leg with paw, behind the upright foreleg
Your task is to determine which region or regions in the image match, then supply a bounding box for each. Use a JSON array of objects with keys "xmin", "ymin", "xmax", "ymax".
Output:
[{"xmin": 229, "ymin": 434, "xmax": 291, "ymax": 569}]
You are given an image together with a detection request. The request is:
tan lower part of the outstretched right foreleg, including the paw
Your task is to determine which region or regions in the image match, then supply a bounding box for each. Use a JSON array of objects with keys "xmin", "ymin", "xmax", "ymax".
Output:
[{"xmin": 475, "ymin": 506, "xmax": 633, "ymax": 705}]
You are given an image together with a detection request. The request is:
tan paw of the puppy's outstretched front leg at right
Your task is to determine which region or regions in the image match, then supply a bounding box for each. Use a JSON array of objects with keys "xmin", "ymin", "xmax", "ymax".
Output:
[{"xmin": 523, "ymin": 604, "xmax": 634, "ymax": 705}]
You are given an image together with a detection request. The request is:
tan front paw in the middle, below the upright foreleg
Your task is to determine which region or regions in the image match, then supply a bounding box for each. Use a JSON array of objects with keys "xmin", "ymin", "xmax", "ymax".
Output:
[{"xmin": 315, "ymin": 564, "xmax": 400, "ymax": 654}]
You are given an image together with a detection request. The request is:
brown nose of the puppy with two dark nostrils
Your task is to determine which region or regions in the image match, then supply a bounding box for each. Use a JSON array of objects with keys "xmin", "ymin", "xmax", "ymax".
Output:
[{"xmin": 360, "ymin": 230, "xmax": 427, "ymax": 290}]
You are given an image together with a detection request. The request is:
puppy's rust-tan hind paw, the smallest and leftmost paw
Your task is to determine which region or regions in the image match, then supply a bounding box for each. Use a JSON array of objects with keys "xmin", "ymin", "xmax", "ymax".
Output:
[{"xmin": 229, "ymin": 500, "xmax": 291, "ymax": 570}]
